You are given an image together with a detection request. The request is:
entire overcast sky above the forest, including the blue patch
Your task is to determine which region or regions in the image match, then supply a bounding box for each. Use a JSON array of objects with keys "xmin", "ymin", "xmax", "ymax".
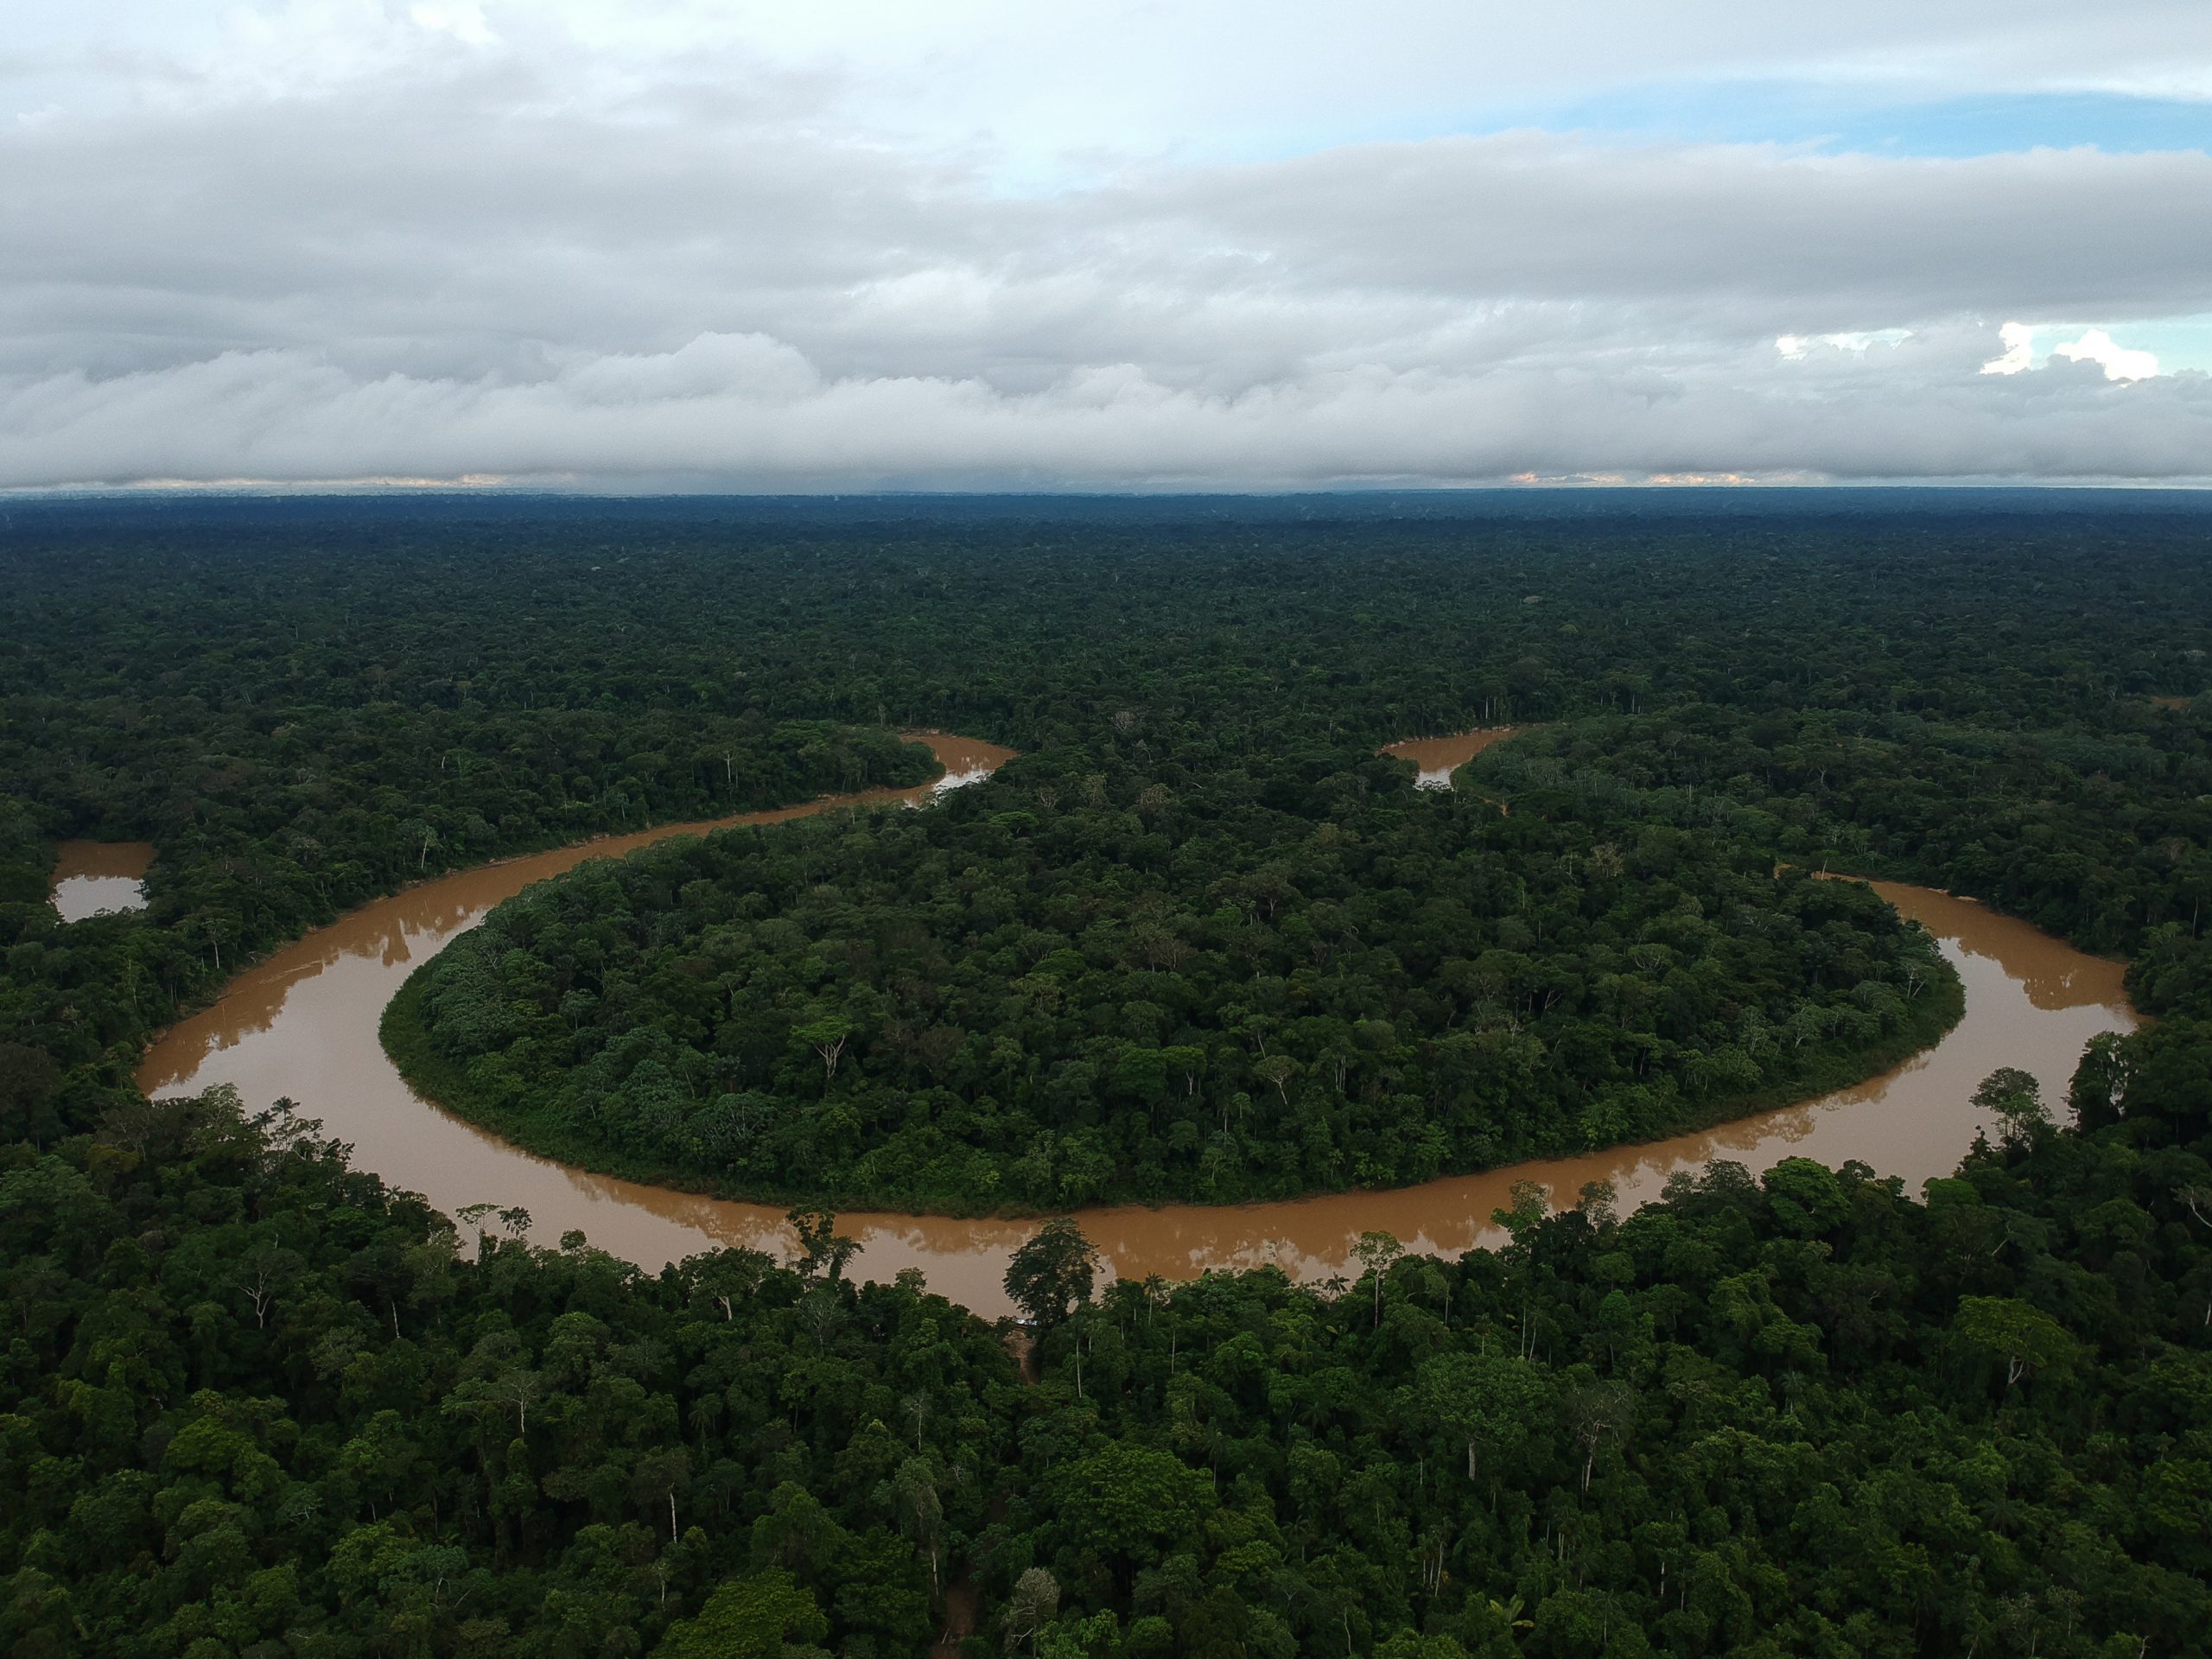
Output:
[{"xmin": 0, "ymin": 0, "xmax": 2212, "ymax": 491}]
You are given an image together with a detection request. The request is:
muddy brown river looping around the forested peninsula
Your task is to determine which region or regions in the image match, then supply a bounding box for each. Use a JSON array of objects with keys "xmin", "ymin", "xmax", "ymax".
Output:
[{"xmin": 139, "ymin": 732, "xmax": 2134, "ymax": 1316}]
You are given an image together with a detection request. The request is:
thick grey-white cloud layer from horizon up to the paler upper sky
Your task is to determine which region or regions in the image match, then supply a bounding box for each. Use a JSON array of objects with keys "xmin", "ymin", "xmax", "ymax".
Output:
[{"xmin": 0, "ymin": 4, "xmax": 2212, "ymax": 489}]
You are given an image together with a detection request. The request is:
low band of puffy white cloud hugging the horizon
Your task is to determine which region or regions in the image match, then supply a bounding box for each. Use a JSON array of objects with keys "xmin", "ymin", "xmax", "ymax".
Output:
[{"xmin": 13, "ymin": 336, "xmax": 2212, "ymax": 489}]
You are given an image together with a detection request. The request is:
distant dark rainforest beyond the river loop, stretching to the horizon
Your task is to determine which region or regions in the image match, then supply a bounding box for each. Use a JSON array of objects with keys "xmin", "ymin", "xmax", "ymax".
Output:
[{"xmin": 0, "ymin": 493, "xmax": 2212, "ymax": 1092}]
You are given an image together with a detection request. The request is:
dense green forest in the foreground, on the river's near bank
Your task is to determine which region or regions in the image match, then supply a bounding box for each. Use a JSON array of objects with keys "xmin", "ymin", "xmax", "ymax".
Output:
[{"xmin": 0, "ymin": 1022, "xmax": 2212, "ymax": 1659}]
